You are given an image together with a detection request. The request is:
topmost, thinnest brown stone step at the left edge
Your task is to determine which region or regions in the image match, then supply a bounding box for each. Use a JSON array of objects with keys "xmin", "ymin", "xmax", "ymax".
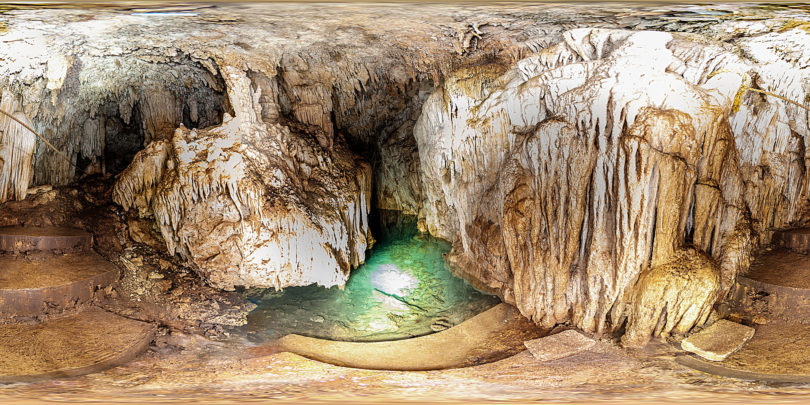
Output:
[{"xmin": 0, "ymin": 227, "xmax": 93, "ymax": 252}]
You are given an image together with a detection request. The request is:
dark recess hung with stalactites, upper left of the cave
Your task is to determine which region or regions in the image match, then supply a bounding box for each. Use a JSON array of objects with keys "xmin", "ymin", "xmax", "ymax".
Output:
[{"xmin": 26, "ymin": 55, "xmax": 233, "ymax": 185}]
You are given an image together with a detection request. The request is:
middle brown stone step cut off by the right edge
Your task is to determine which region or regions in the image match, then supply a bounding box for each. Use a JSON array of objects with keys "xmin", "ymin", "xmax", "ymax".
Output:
[{"xmin": 730, "ymin": 248, "xmax": 810, "ymax": 323}]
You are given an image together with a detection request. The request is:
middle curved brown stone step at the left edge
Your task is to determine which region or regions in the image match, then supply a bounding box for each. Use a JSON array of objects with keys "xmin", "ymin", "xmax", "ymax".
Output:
[{"xmin": 0, "ymin": 251, "xmax": 119, "ymax": 318}]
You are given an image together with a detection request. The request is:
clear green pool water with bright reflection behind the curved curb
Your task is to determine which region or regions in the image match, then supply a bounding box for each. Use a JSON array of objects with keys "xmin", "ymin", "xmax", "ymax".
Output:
[{"xmin": 244, "ymin": 224, "xmax": 500, "ymax": 343}]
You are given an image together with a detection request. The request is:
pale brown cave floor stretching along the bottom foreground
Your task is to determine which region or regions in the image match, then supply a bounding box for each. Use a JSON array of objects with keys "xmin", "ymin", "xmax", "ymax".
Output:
[{"xmin": 0, "ymin": 334, "xmax": 810, "ymax": 403}]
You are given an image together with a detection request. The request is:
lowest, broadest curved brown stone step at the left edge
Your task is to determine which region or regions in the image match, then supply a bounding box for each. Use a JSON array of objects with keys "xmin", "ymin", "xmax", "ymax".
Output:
[{"xmin": 0, "ymin": 309, "xmax": 156, "ymax": 382}]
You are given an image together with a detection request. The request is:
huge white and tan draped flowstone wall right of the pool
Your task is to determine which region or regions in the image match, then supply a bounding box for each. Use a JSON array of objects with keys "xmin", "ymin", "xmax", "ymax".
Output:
[{"xmin": 414, "ymin": 29, "xmax": 810, "ymax": 345}]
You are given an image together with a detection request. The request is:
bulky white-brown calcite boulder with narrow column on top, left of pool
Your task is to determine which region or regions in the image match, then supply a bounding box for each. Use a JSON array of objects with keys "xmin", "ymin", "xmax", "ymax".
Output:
[{"xmin": 113, "ymin": 77, "xmax": 371, "ymax": 289}]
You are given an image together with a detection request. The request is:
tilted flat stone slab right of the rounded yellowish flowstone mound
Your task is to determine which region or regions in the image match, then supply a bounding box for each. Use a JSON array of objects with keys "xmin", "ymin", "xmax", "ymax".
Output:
[{"xmin": 681, "ymin": 319, "xmax": 754, "ymax": 361}]
